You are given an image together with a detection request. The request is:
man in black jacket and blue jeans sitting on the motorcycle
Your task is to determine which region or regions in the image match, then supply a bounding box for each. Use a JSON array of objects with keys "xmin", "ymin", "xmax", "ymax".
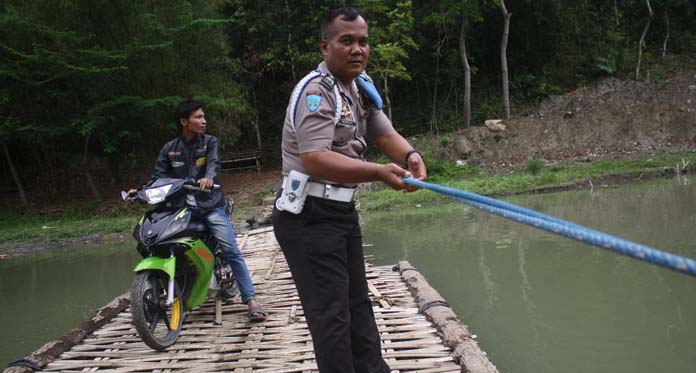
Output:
[{"xmin": 129, "ymin": 100, "xmax": 266, "ymax": 321}]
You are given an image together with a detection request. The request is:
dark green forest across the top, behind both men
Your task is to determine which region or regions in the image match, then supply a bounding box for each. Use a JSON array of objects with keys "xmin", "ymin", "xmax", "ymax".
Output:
[{"xmin": 0, "ymin": 0, "xmax": 696, "ymax": 203}]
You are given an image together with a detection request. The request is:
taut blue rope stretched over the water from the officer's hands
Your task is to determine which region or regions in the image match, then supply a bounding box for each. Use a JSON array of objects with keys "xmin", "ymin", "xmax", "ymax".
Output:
[{"xmin": 404, "ymin": 177, "xmax": 696, "ymax": 277}]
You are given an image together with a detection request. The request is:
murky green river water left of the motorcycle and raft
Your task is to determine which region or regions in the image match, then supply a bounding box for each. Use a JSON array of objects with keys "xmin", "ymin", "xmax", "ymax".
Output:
[{"xmin": 0, "ymin": 241, "xmax": 140, "ymax": 369}]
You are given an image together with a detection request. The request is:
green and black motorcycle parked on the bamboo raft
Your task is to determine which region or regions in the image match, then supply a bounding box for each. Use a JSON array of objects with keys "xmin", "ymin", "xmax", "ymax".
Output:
[{"xmin": 123, "ymin": 178, "xmax": 238, "ymax": 351}]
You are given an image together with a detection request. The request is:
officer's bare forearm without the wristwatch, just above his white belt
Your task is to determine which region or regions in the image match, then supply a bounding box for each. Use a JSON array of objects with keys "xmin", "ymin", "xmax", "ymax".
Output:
[{"xmin": 300, "ymin": 150, "xmax": 411, "ymax": 190}]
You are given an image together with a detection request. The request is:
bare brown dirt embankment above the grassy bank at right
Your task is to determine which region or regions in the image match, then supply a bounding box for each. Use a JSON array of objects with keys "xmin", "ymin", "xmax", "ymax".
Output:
[{"xmin": 448, "ymin": 72, "xmax": 696, "ymax": 168}]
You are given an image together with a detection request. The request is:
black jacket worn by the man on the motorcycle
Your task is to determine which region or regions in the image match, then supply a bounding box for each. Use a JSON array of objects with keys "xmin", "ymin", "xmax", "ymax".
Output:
[{"xmin": 145, "ymin": 134, "xmax": 225, "ymax": 214}]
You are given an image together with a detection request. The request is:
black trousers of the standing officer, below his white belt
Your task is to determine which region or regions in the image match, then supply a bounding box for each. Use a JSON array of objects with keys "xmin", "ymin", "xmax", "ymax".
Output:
[{"xmin": 273, "ymin": 196, "xmax": 390, "ymax": 373}]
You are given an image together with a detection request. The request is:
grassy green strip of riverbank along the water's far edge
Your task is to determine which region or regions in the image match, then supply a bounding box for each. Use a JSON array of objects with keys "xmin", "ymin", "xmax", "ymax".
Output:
[{"xmin": 0, "ymin": 150, "xmax": 696, "ymax": 259}]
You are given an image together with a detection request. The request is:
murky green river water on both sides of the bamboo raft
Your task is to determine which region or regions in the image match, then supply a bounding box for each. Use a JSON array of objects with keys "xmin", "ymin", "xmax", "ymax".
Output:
[{"xmin": 0, "ymin": 179, "xmax": 696, "ymax": 373}]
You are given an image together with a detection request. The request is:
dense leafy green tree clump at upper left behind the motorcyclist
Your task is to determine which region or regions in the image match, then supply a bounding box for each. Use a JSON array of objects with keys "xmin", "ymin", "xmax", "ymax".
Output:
[{"xmin": 0, "ymin": 0, "xmax": 249, "ymax": 201}]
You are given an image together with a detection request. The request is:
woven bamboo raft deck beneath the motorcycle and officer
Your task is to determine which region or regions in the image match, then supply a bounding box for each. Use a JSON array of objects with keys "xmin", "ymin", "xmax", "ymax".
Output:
[{"xmin": 5, "ymin": 228, "xmax": 497, "ymax": 373}]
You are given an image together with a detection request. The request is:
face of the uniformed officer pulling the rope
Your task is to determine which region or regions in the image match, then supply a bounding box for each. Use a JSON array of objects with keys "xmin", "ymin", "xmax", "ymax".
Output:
[{"xmin": 321, "ymin": 17, "xmax": 370, "ymax": 85}]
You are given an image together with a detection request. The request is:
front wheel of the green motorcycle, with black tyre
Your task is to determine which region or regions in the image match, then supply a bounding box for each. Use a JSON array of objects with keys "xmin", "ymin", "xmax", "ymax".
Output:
[{"xmin": 131, "ymin": 270, "xmax": 184, "ymax": 351}]
